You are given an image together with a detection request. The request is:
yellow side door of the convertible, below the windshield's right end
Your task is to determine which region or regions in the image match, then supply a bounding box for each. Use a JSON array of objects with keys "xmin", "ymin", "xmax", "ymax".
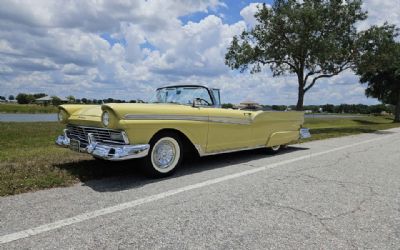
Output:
[{"xmin": 206, "ymin": 108, "xmax": 254, "ymax": 153}]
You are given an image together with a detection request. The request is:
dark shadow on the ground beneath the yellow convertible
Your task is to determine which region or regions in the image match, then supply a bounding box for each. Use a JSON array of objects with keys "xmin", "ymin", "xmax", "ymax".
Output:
[{"xmin": 54, "ymin": 146, "xmax": 308, "ymax": 192}]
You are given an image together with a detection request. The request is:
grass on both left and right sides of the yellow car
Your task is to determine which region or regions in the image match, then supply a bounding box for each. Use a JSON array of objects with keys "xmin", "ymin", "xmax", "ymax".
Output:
[{"xmin": 0, "ymin": 117, "xmax": 400, "ymax": 196}]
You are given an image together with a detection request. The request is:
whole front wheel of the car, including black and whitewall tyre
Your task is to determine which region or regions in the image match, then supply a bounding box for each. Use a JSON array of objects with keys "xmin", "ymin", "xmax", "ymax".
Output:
[{"xmin": 144, "ymin": 133, "xmax": 183, "ymax": 177}]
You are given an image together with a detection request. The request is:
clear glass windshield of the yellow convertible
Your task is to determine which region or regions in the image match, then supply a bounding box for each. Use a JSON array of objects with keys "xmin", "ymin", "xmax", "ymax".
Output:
[{"xmin": 153, "ymin": 86, "xmax": 212, "ymax": 106}]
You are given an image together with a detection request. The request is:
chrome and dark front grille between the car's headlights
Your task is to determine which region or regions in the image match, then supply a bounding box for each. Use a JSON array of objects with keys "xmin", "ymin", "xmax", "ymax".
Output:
[{"xmin": 67, "ymin": 124, "xmax": 127, "ymax": 145}]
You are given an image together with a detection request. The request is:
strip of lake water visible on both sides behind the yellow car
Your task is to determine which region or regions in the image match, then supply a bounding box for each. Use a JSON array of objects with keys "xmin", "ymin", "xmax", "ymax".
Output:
[{"xmin": 0, "ymin": 114, "xmax": 362, "ymax": 122}]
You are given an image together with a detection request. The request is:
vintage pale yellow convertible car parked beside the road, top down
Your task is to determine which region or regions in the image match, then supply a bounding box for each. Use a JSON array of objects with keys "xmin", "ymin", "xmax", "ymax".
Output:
[{"xmin": 56, "ymin": 85, "xmax": 310, "ymax": 176}]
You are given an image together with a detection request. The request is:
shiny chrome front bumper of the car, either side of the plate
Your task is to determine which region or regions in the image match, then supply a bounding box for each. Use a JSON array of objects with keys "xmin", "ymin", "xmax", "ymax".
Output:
[{"xmin": 56, "ymin": 129, "xmax": 150, "ymax": 161}]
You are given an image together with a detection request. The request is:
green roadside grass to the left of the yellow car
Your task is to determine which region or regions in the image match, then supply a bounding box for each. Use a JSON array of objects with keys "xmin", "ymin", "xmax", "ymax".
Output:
[{"xmin": 0, "ymin": 122, "xmax": 144, "ymax": 196}]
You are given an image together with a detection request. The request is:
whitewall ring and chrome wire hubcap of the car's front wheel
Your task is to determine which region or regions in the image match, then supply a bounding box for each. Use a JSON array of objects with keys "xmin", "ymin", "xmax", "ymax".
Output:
[{"xmin": 151, "ymin": 137, "xmax": 180, "ymax": 173}]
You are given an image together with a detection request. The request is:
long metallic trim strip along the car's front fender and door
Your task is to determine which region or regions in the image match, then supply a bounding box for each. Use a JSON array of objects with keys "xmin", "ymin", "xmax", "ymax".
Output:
[{"xmin": 124, "ymin": 114, "xmax": 252, "ymax": 125}]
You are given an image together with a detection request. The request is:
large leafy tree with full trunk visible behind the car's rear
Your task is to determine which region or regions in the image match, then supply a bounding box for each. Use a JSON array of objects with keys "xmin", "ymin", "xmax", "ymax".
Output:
[{"xmin": 225, "ymin": 0, "xmax": 367, "ymax": 110}]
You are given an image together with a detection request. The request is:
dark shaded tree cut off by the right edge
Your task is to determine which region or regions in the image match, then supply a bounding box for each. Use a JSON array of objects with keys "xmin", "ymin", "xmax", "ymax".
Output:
[{"xmin": 355, "ymin": 23, "xmax": 400, "ymax": 122}]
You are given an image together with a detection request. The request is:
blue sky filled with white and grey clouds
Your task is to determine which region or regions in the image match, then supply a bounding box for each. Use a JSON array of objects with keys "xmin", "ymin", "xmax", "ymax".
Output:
[{"xmin": 0, "ymin": 0, "xmax": 400, "ymax": 105}]
